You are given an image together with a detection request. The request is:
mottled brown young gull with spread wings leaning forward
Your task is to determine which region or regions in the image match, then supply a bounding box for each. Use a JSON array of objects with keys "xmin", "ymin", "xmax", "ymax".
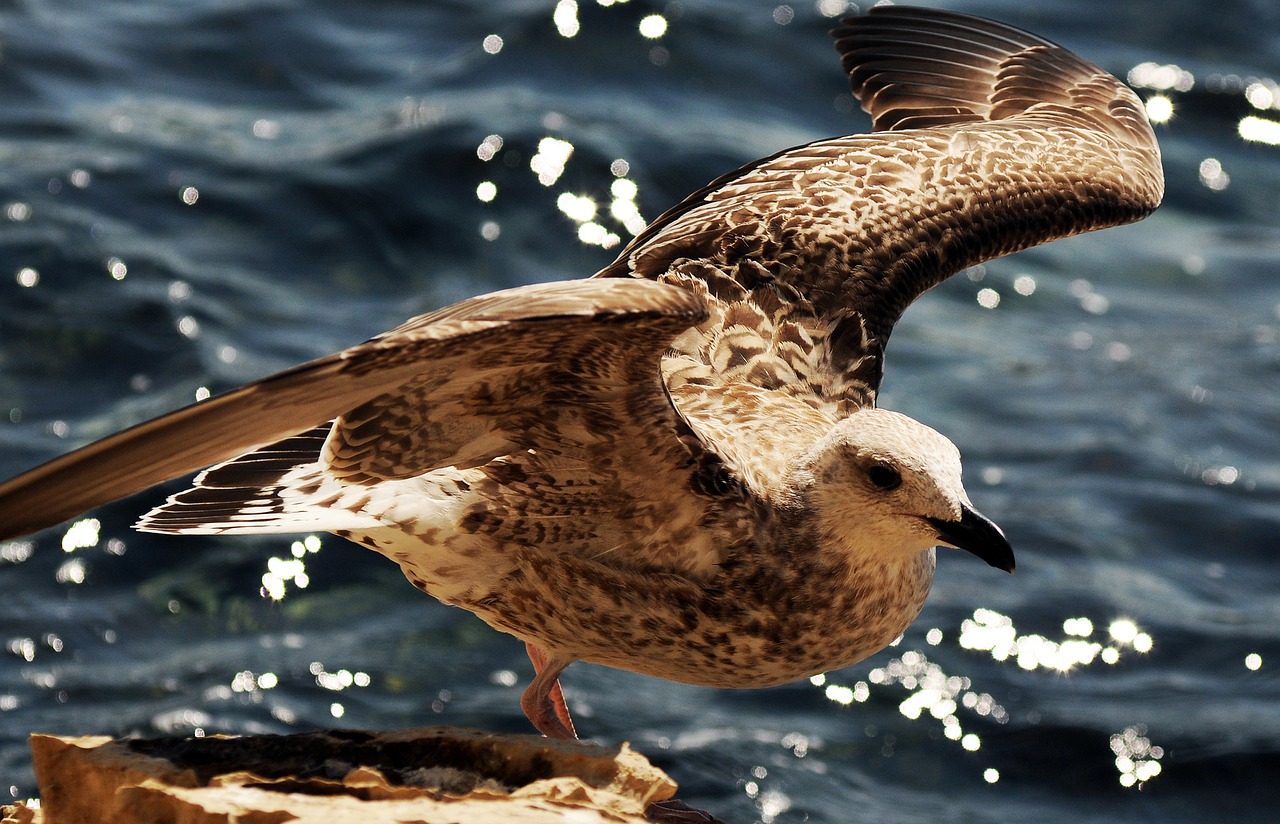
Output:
[{"xmin": 0, "ymin": 6, "xmax": 1164, "ymax": 752}]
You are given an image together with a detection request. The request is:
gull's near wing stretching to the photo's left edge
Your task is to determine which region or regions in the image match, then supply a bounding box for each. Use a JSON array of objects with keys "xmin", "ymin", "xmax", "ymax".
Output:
[{"xmin": 0, "ymin": 280, "xmax": 707, "ymax": 540}]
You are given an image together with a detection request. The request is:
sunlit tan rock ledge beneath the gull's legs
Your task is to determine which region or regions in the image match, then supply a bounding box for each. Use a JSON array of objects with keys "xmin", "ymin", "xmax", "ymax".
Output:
[{"xmin": 24, "ymin": 727, "xmax": 676, "ymax": 824}]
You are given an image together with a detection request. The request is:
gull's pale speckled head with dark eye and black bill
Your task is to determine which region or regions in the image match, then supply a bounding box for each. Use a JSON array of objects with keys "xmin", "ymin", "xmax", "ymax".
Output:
[{"xmin": 796, "ymin": 408, "xmax": 1014, "ymax": 572}]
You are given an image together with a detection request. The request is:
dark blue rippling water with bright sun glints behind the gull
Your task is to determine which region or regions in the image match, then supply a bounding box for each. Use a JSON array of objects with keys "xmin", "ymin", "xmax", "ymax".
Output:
[{"xmin": 0, "ymin": 0, "xmax": 1280, "ymax": 823}]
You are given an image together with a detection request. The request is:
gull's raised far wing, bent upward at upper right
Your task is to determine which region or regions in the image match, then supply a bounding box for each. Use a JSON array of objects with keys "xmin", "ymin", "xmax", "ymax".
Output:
[{"xmin": 600, "ymin": 6, "xmax": 1164, "ymax": 403}]
